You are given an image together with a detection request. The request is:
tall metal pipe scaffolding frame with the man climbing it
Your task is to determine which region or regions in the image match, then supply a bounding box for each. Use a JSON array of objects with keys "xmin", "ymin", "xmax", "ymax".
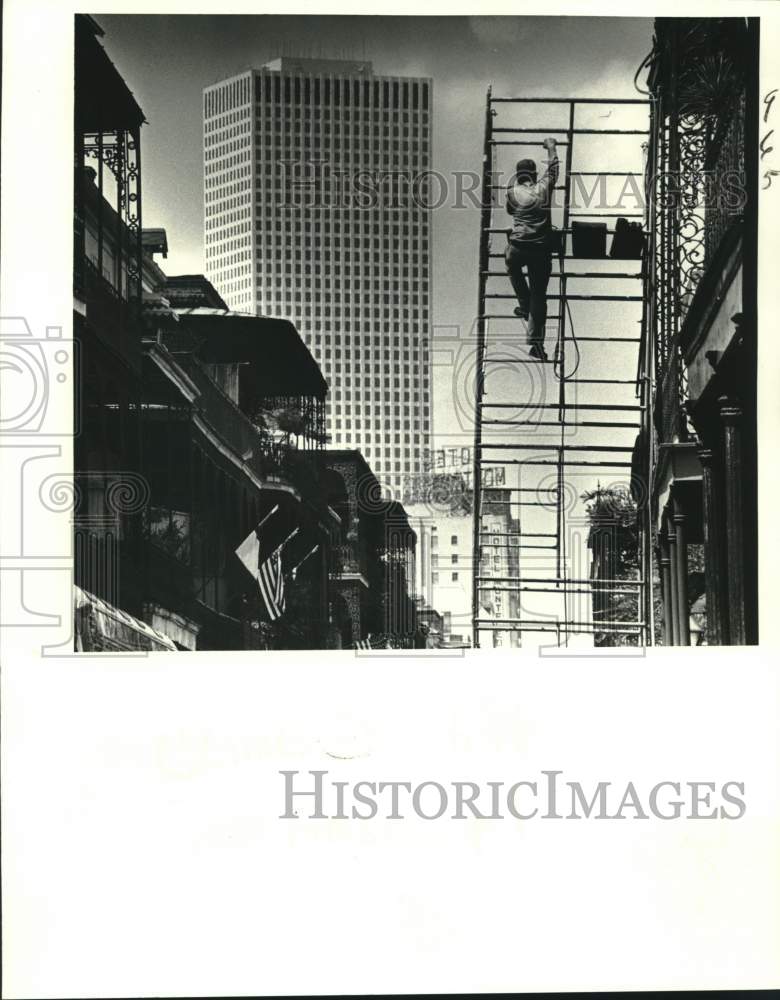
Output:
[{"xmin": 472, "ymin": 89, "xmax": 653, "ymax": 647}]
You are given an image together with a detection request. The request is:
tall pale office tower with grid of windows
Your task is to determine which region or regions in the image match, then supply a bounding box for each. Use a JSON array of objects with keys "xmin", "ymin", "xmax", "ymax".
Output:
[{"xmin": 203, "ymin": 57, "xmax": 432, "ymax": 492}]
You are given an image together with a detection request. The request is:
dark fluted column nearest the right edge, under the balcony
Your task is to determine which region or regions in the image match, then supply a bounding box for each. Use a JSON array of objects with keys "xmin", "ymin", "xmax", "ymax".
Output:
[{"xmin": 718, "ymin": 396, "xmax": 745, "ymax": 646}]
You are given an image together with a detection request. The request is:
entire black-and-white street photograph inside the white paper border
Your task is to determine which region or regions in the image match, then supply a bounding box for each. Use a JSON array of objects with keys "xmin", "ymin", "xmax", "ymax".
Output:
[{"xmin": 74, "ymin": 14, "xmax": 760, "ymax": 651}]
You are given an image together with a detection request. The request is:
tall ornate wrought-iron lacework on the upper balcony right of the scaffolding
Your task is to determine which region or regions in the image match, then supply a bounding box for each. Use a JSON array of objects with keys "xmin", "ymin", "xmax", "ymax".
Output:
[{"xmin": 645, "ymin": 18, "xmax": 746, "ymax": 441}]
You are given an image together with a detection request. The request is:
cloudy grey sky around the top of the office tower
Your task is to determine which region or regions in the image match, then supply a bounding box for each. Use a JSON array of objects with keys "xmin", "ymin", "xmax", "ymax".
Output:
[{"xmin": 96, "ymin": 15, "xmax": 652, "ymax": 437}]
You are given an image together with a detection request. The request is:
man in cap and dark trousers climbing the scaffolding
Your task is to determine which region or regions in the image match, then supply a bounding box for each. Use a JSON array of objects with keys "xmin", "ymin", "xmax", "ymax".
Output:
[{"xmin": 506, "ymin": 139, "xmax": 559, "ymax": 361}]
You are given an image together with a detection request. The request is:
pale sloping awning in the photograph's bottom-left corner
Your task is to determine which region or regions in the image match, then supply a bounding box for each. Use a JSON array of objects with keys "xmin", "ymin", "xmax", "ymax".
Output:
[{"xmin": 73, "ymin": 587, "xmax": 176, "ymax": 653}]
